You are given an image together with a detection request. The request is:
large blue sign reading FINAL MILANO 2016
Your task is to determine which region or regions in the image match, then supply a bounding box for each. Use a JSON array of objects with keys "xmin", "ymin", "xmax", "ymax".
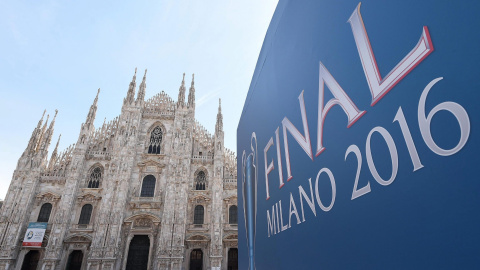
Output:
[{"xmin": 237, "ymin": 0, "xmax": 480, "ymax": 270}]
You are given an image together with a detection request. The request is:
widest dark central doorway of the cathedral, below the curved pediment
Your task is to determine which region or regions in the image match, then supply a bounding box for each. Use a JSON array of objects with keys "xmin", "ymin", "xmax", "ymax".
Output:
[{"xmin": 125, "ymin": 235, "xmax": 150, "ymax": 270}]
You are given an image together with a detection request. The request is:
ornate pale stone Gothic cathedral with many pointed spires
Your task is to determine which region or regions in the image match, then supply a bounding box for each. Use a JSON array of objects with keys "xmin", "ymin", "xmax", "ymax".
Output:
[{"xmin": 0, "ymin": 70, "xmax": 238, "ymax": 270}]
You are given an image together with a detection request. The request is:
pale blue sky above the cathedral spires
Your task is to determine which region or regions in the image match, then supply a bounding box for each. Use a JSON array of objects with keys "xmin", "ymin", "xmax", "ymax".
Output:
[{"xmin": 0, "ymin": 0, "xmax": 278, "ymax": 199}]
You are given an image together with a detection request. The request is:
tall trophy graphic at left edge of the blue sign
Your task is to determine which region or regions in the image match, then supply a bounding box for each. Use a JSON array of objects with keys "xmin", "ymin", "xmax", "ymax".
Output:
[{"xmin": 242, "ymin": 132, "xmax": 258, "ymax": 270}]
